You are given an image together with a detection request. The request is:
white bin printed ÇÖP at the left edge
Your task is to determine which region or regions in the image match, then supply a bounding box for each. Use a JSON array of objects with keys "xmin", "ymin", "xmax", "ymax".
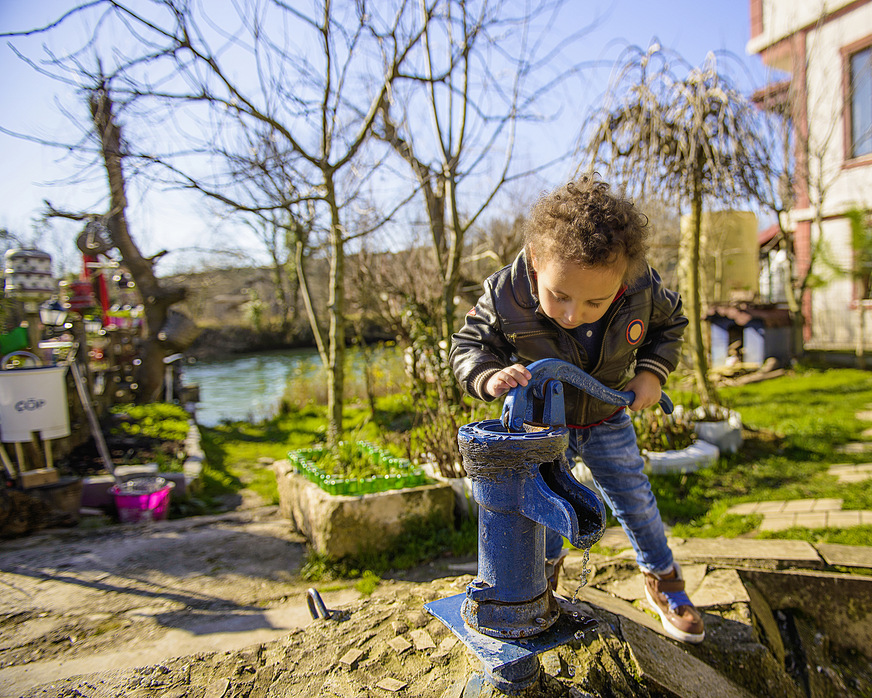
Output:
[{"xmin": 0, "ymin": 354, "xmax": 70, "ymax": 443}]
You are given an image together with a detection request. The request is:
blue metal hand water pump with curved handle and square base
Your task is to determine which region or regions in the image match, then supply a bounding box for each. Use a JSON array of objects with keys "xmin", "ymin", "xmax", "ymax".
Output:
[{"xmin": 425, "ymin": 359, "xmax": 672, "ymax": 692}]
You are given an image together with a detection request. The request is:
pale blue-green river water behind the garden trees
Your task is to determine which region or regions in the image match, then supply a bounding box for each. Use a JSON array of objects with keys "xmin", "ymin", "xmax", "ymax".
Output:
[{"xmin": 182, "ymin": 350, "xmax": 321, "ymax": 426}]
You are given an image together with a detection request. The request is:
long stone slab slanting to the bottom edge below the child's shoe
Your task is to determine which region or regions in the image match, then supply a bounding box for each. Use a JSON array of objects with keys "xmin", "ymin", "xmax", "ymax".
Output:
[{"xmin": 621, "ymin": 621, "xmax": 751, "ymax": 698}]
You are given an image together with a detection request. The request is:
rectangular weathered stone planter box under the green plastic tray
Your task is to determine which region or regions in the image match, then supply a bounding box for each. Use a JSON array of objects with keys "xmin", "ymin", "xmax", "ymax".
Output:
[{"xmin": 272, "ymin": 460, "xmax": 454, "ymax": 560}]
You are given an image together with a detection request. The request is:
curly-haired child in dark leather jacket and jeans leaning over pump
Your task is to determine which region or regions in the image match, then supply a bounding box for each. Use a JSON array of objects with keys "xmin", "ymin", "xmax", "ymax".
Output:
[{"xmin": 451, "ymin": 175, "xmax": 705, "ymax": 643}]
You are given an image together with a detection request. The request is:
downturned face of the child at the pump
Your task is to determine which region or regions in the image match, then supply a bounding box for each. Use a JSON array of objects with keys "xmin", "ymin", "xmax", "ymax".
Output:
[{"xmin": 533, "ymin": 254, "xmax": 627, "ymax": 330}]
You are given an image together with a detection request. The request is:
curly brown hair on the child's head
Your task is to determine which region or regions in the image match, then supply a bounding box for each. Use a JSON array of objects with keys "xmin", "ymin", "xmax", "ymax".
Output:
[{"xmin": 524, "ymin": 173, "xmax": 649, "ymax": 281}]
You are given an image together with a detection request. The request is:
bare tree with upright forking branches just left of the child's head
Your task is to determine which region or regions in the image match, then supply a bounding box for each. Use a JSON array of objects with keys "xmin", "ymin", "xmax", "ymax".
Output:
[{"xmin": 376, "ymin": 0, "xmax": 588, "ymax": 340}]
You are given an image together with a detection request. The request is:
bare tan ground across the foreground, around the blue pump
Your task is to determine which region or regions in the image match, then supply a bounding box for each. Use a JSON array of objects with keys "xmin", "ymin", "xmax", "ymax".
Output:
[{"xmin": 6, "ymin": 498, "xmax": 872, "ymax": 698}]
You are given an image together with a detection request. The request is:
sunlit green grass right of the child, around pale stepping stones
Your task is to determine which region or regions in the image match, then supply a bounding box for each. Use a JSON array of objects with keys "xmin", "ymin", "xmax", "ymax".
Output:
[{"xmin": 652, "ymin": 369, "xmax": 872, "ymax": 545}]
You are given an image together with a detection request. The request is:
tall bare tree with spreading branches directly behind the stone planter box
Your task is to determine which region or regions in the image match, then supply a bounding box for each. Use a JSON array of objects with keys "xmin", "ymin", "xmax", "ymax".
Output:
[{"xmin": 5, "ymin": 0, "xmax": 438, "ymax": 445}]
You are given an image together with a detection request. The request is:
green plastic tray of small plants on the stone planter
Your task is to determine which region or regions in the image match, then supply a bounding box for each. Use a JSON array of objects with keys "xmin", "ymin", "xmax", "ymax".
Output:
[{"xmin": 288, "ymin": 441, "xmax": 430, "ymax": 495}]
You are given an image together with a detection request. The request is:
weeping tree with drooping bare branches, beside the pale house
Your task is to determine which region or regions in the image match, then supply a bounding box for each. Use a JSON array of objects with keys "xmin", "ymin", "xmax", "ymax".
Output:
[{"xmin": 579, "ymin": 44, "xmax": 775, "ymax": 405}]
